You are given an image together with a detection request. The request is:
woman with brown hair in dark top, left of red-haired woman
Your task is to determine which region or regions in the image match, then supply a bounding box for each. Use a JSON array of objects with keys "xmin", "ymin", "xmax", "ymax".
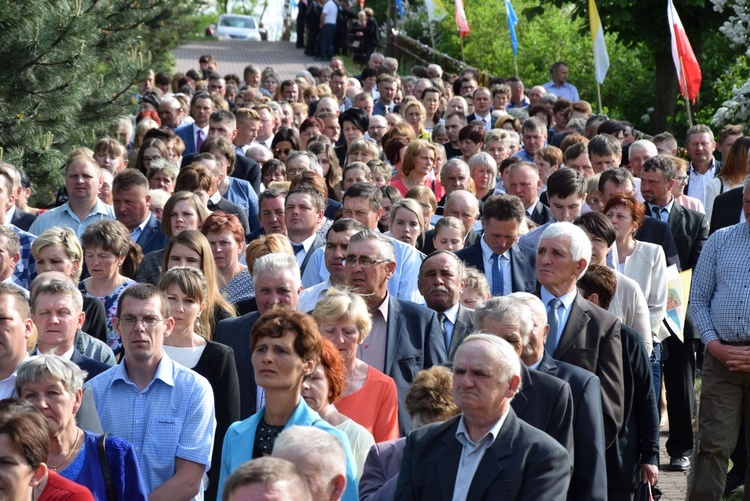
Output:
[{"xmin": 135, "ymin": 191, "xmax": 208, "ymax": 285}]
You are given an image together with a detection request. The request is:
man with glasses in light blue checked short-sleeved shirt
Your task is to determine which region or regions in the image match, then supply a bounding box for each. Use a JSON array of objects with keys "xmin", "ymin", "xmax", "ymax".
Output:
[{"xmin": 88, "ymin": 284, "xmax": 215, "ymax": 500}]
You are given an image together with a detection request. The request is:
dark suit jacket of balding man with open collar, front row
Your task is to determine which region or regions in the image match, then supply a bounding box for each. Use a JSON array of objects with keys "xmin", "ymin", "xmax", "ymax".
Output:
[{"xmin": 394, "ymin": 409, "xmax": 571, "ymax": 501}]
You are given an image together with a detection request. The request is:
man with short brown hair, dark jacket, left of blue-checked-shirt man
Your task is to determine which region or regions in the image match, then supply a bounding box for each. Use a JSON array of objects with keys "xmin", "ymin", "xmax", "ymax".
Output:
[{"xmin": 31, "ymin": 278, "xmax": 109, "ymax": 381}]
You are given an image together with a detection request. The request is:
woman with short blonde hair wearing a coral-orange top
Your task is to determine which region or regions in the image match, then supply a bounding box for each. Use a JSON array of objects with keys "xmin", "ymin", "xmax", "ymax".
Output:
[{"xmin": 312, "ymin": 288, "xmax": 399, "ymax": 442}]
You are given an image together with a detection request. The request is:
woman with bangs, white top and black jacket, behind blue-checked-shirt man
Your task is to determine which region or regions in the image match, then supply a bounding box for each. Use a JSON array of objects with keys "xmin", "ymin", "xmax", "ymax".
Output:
[{"xmin": 159, "ymin": 266, "xmax": 240, "ymax": 499}]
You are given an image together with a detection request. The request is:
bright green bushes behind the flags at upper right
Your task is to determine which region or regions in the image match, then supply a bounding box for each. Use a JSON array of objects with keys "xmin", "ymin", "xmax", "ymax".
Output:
[{"xmin": 407, "ymin": 0, "xmax": 654, "ymax": 130}]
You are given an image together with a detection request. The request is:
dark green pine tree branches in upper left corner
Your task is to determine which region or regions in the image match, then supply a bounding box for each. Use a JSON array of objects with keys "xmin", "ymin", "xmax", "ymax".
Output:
[{"xmin": 0, "ymin": 0, "xmax": 203, "ymax": 204}]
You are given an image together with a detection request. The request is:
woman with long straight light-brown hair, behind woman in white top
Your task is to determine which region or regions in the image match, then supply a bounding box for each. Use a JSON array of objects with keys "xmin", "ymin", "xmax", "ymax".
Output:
[{"xmin": 162, "ymin": 230, "xmax": 237, "ymax": 332}]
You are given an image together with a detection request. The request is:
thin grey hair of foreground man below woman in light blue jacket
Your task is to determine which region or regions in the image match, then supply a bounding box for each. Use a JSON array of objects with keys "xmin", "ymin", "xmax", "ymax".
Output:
[{"xmin": 271, "ymin": 426, "xmax": 346, "ymax": 484}]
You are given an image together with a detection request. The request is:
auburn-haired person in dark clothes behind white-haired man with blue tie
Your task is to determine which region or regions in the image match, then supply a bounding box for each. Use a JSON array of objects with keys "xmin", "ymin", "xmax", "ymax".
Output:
[{"xmin": 578, "ymin": 265, "xmax": 659, "ymax": 501}]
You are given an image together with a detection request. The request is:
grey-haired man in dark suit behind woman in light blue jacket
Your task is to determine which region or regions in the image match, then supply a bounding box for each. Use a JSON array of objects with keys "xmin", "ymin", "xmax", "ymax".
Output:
[{"xmin": 214, "ymin": 254, "xmax": 302, "ymax": 419}]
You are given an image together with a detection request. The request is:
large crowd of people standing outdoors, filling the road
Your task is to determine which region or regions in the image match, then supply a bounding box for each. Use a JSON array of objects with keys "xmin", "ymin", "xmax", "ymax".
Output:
[{"xmin": 0, "ymin": 41, "xmax": 750, "ymax": 501}]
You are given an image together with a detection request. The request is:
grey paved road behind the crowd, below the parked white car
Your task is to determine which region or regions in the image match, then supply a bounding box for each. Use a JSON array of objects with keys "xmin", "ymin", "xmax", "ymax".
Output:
[{"xmin": 173, "ymin": 40, "xmax": 321, "ymax": 80}]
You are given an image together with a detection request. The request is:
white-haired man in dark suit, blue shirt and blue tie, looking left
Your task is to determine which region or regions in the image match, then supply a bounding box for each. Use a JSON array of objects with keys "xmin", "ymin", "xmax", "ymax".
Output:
[{"xmin": 536, "ymin": 223, "xmax": 624, "ymax": 446}]
